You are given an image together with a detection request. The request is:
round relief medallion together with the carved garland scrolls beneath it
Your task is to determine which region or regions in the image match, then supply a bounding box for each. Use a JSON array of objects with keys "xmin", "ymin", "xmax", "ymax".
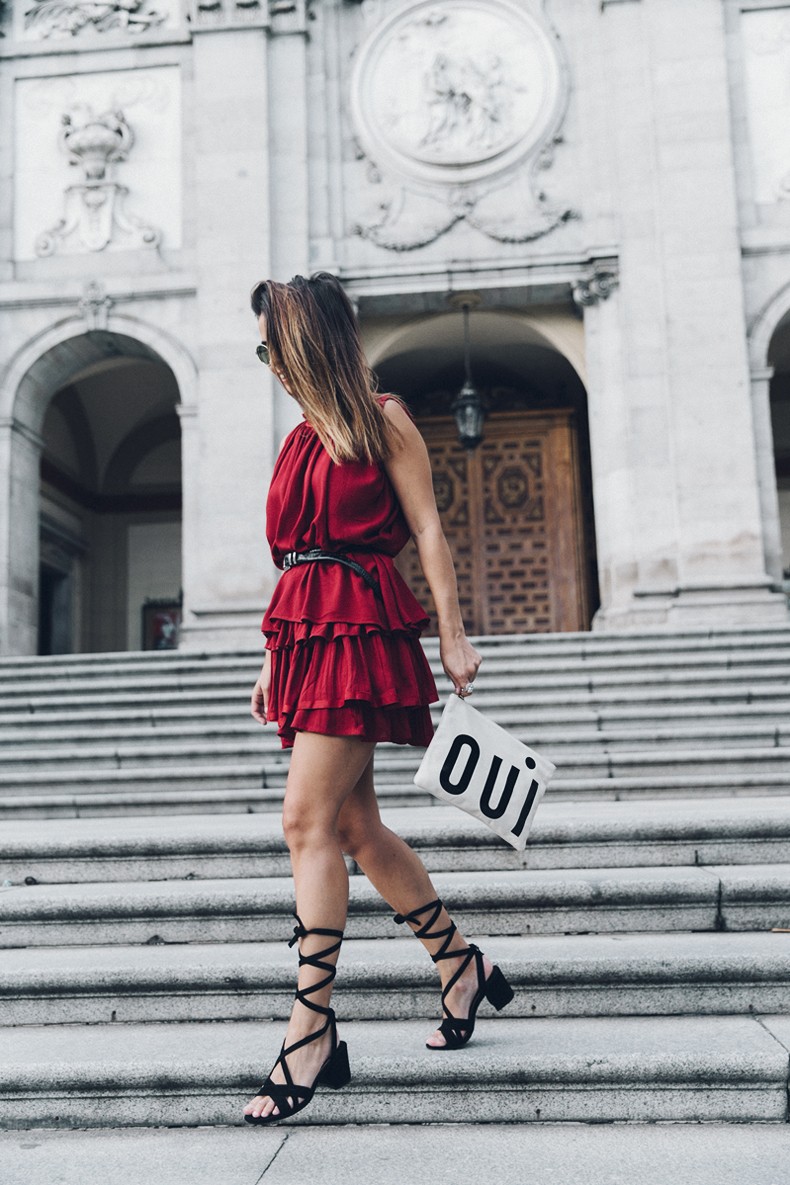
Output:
[{"xmin": 351, "ymin": 0, "xmax": 571, "ymax": 250}]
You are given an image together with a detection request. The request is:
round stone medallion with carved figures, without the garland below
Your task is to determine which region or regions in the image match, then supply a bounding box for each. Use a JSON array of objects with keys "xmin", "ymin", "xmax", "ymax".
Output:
[{"xmin": 352, "ymin": 0, "xmax": 560, "ymax": 184}]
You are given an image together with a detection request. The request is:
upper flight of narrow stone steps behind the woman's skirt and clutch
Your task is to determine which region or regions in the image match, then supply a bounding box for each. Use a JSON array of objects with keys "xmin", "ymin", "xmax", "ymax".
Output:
[{"xmin": 0, "ymin": 629, "xmax": 790, "ymax": 818}]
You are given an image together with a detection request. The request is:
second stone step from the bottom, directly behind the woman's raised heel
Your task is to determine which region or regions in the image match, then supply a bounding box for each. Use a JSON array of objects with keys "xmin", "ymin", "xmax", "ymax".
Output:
[{"xmin": 0, "ymin": 933, "xmax": 790, "ymax": 1025}]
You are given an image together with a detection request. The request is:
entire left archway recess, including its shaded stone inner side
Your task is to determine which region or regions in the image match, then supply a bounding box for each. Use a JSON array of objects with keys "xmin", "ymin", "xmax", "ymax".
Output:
[{"xmin": 6, "ymin": 329, "xmax": 181, "ymax": 654}]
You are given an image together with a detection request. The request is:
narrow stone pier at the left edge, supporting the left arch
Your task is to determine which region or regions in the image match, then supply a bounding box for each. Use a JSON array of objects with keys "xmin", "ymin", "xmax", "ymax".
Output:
[{"xmin": 0, "ymin": 419, "xmax": 44, "ymax": 654}]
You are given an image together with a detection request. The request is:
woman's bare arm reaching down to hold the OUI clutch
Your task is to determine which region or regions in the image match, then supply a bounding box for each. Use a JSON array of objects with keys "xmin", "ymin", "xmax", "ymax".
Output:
[{"xmin": 384, "ymin": 399, "xmax": 482, "ymax": 692}]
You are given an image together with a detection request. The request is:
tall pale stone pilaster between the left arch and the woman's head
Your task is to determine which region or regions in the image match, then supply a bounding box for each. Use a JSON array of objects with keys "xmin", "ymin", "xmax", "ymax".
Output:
[{"xmin": 181, "ymin": 16, "xmax": 275, "ymax": 648}]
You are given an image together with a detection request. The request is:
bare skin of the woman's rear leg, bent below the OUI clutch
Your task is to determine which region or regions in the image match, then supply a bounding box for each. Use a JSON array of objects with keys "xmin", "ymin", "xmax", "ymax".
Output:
[{"xmin": 338, "ymin": 755, "xmax": 493, "ymax": 1048}]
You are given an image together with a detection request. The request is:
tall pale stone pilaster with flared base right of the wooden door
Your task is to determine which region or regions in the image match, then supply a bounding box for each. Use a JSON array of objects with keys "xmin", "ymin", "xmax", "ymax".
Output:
[{"xmin": 591, "ymin": 0, "xmax": 788, "ymax": 629}]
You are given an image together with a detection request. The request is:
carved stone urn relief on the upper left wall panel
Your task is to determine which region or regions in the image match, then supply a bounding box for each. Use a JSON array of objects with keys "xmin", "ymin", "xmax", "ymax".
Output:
[{"xmin": 36, "ymin": 105, "xmax": 160, "ymax": 255}]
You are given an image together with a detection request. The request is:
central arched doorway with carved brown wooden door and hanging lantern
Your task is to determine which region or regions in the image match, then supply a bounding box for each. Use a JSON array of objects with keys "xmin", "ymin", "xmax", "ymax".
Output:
[{"xmin": 375, "ymin": 312, "xmax": 598, "ymax": 634}]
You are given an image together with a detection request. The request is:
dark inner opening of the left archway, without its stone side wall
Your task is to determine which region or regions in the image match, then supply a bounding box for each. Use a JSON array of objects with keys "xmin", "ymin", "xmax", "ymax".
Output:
[{"xmin": 38, "ymin": 356, "xmax": 181, "ymax": 654}]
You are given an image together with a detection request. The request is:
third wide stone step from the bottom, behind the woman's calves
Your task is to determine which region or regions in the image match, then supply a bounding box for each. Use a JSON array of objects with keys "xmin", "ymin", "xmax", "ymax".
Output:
[{"xmin": 0, "ymin": 864, "xmax": 790, "ymax": 947}]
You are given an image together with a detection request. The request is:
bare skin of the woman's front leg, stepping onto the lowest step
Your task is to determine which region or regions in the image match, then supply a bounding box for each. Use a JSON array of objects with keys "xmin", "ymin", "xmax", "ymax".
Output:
[{"xmin": 244, "ymin": 732, "xmax": 374, "ymax": 1116}]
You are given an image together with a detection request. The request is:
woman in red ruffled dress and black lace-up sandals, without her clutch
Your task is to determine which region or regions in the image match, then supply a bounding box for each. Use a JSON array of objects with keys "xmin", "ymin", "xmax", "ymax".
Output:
[{"xmin": 244, "ymin": 273, "xmax": 513, "ymax": 1123}]
